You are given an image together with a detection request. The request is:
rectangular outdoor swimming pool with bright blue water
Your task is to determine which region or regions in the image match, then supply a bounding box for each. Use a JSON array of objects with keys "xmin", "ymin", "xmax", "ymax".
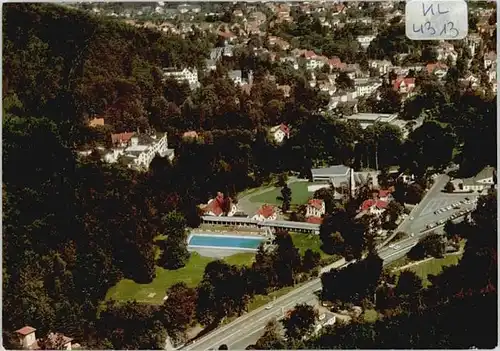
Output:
[{"xmin": 188, "ymin": 234, "xmax": 265, "ymax": 251}]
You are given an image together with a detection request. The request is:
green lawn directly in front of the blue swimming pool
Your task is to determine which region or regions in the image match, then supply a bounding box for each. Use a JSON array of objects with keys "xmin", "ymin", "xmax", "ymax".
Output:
[{"xmin": 106, "ymin": 252, "xmax": 255, "ymax": 304}]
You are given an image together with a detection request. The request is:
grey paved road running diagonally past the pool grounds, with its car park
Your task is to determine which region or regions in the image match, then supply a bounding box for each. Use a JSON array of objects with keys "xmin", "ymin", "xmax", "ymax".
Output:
[{"xmin": 183, "ymin": 175, "xmax": 475, "ymax": 350}]
